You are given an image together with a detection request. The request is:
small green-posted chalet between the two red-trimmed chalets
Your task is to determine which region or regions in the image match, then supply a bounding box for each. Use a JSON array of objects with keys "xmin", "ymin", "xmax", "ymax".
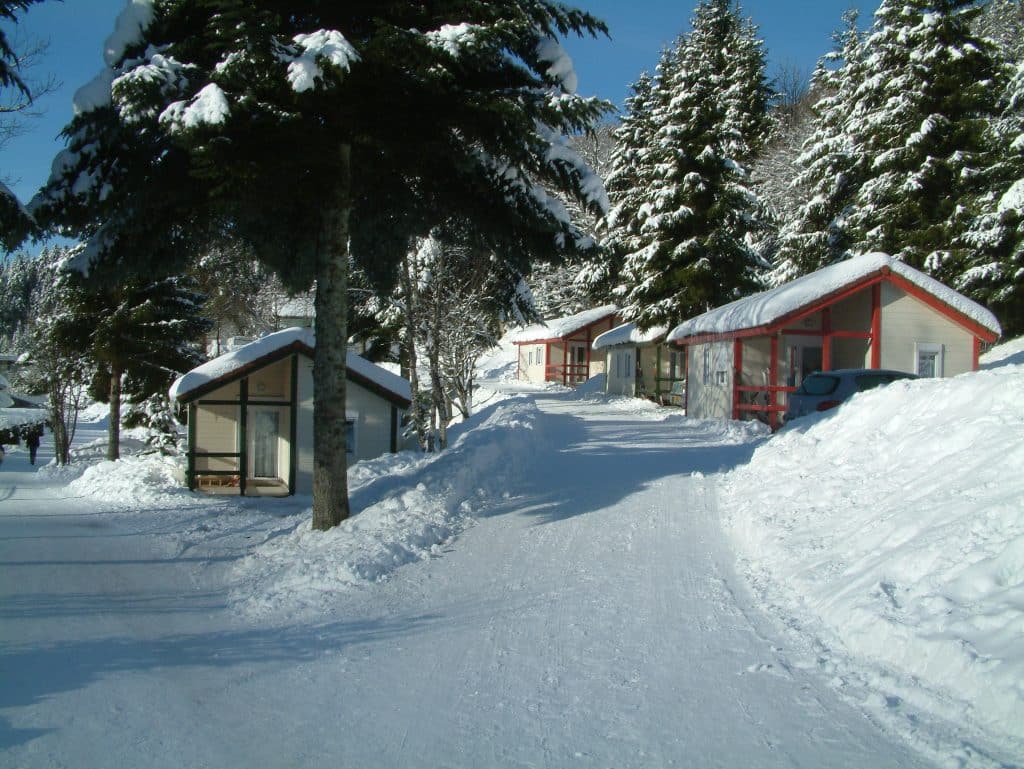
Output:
[{"xmin": 593, "ymin": 323, "xmax": 686, "ymax": 405}]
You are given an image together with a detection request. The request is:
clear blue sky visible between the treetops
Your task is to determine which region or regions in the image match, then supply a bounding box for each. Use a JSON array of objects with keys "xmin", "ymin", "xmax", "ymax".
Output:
[{"xmin": 0, "ymin": 0, "xmax": 879, "ymax": 207}]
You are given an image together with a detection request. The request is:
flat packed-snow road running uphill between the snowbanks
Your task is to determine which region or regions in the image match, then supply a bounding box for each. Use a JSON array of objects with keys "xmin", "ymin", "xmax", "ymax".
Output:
[{"xmin": 0, "ymin": 392, "xmax": 930, "ymax": 769}]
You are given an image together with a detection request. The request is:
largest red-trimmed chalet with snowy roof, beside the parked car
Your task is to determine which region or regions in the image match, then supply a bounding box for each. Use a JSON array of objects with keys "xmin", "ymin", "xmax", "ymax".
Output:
[{"xmin": 668, "ymin": 253, "xmax": 1000, "ymax": 427}]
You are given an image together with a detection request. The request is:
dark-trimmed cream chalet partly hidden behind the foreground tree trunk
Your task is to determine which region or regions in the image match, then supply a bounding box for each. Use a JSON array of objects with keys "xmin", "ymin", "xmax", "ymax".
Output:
[{"xmin": 170, "ymin": 328, "xmax": 412, "ymax": 496}]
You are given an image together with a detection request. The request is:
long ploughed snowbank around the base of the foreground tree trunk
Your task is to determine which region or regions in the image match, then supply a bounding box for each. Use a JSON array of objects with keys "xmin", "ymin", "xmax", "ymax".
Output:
[{"xmin": 231, "ymin": 398, "xmax": 540, "ymax": 616}]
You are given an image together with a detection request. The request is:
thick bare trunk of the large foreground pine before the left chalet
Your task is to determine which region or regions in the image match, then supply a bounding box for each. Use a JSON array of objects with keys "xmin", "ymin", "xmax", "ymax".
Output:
[{"xmin": 313, "ymin": 144, "xmax": 352, "ymax": 531}]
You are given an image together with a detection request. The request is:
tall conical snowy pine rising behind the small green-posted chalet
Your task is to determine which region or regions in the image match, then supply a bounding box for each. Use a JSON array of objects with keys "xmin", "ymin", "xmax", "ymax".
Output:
[{"xmin": 624, "ymin": 0, "xmax": 767, "ymax": 328}]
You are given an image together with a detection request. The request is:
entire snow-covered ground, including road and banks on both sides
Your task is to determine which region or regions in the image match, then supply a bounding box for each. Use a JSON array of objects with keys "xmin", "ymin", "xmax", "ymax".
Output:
[{"xmin": 0, "ymin": 348, "xmax": 1024, "ymax": 768}]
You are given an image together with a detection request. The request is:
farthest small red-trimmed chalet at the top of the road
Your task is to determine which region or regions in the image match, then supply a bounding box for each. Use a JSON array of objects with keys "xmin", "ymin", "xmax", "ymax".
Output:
[{"xmin": 512, "ymin": 304, "xmax": 617, "ymax": 387}]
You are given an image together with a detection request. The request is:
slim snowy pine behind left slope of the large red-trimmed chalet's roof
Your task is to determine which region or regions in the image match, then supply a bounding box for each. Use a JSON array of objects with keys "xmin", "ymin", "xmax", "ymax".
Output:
[{"xmin": 769, "ymin": 10, "xmax": 865, "ymax": 285}]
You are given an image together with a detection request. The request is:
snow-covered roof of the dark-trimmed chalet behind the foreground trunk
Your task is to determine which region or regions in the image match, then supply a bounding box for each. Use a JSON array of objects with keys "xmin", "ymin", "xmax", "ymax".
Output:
[{"xmin": 169, "ymin": 327, "xmax": 413, "ymax": 401}]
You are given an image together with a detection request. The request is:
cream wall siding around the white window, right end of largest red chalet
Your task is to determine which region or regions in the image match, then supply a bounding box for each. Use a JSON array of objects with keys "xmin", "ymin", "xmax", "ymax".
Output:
[{"xmin": 882, "ymin": 283, "xmax": 974, "ymax": 377}]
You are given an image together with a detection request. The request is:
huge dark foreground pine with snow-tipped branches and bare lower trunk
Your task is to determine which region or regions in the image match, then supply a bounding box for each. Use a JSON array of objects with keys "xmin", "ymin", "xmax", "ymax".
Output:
[{"xmin": 44, "ymin": 0, "xmax": 606, "ymax": 528}]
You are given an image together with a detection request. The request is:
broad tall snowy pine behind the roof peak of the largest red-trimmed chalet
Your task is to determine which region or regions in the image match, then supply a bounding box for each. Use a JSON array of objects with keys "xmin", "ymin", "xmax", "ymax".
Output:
[{"xmin": 847, "ymin": 0, "xmax": 1000, "ymax": 285}]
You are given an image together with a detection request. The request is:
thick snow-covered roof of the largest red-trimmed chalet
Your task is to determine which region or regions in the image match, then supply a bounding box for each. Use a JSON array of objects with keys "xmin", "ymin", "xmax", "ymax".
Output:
[{"xmin": 669, "ymin": 253, "xmax": 1001, "ymax": 341}]
